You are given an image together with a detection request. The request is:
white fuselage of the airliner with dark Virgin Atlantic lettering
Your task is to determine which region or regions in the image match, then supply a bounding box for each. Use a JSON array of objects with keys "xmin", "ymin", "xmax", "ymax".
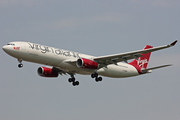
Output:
[{"xmin": 3, "ymin": 42, "xmax": 139, "ymax": 78}]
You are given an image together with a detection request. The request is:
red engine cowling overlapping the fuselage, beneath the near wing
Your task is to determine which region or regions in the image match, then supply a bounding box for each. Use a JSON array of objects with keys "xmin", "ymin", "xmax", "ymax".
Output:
[{"xmin": 76, "ymin": 58, "xmax": 98, "ymax": 69}]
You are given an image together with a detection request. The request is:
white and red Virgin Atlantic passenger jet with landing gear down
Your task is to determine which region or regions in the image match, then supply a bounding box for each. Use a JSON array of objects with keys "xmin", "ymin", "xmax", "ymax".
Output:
[{"xmin": 3, "ymin": 40, "xmax": 177, "ymax": 86}]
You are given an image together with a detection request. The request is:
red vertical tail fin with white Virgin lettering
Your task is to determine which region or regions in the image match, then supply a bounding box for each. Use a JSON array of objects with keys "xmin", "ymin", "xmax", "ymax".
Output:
[{"xmin": 129, "ymin": 45, "xmax": 153, "ymax": 69}]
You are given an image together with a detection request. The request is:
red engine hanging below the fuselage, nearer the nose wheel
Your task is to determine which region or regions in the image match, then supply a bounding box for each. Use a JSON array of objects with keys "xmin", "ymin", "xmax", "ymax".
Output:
[{"xmin": 37, "ymin": 67, "xmax": 59, "ymax": 77}]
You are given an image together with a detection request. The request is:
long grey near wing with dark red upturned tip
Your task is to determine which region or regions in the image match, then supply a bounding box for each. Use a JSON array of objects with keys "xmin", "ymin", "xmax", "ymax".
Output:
[{"xmin": 94, "ymin": 40, "xmax": 177, "ymax": 67}]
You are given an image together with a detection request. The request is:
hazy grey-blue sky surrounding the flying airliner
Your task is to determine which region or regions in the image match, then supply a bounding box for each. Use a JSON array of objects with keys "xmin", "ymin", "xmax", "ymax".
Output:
[{"xmin": 0, "ymin": 0, "xmax": 180, "ymax": 120}]
